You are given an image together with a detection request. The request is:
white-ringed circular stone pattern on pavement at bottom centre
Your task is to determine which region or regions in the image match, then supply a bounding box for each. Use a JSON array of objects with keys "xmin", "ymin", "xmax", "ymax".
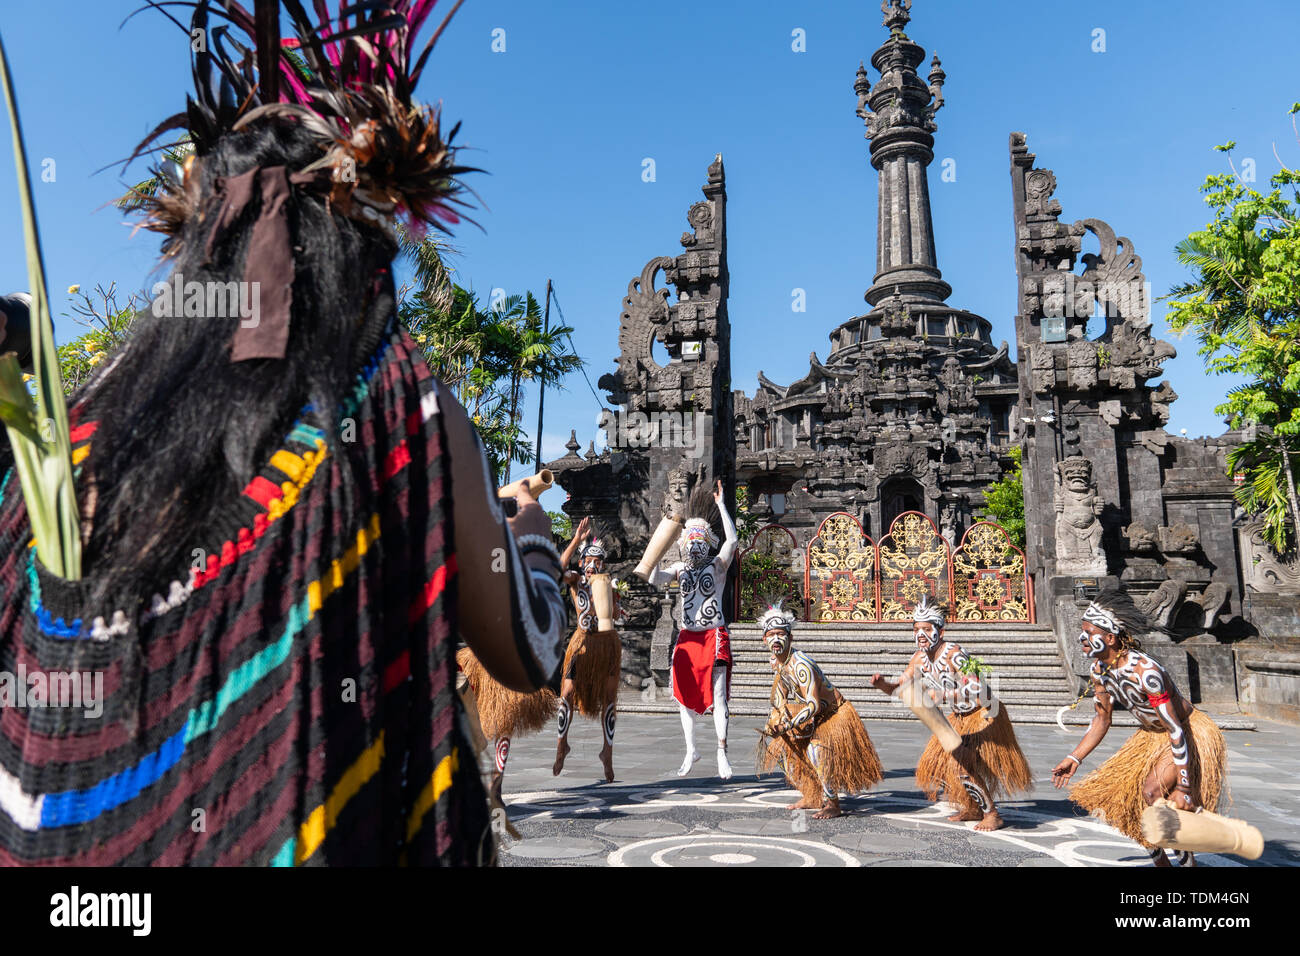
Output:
[{"xmin": 608, "ymin": 832, "xmax": 862, "ymax": 866}]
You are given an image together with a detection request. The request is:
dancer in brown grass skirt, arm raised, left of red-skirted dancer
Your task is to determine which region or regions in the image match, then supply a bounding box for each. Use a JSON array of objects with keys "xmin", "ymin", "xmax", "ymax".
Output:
[{"xmin": 551, "ymin": 518, "xmax": 623, "ymax": 783}]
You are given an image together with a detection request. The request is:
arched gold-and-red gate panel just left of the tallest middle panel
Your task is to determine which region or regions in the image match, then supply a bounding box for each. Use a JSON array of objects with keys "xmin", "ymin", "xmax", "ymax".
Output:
[{"xmin": 805, "ymin": 511, "xmax": 880, "ymax": 620}]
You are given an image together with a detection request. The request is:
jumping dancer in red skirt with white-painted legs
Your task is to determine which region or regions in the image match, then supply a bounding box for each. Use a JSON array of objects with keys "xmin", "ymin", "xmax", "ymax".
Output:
[{"xmin": 650, "ymin": 481, "xmax": 737, "ymax": 780}]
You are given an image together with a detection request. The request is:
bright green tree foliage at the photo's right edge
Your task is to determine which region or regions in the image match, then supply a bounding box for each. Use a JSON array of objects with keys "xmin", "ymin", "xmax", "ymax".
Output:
[{"xmin": 1165, "ymin": 113, "xmax": 1300, "ymax": 553}]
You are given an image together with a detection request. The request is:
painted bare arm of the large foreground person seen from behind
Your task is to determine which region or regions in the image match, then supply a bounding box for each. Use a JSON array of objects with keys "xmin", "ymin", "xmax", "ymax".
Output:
[{"xmin": 436, "ymin": 382, "xmax": 566, "ymax": 692}]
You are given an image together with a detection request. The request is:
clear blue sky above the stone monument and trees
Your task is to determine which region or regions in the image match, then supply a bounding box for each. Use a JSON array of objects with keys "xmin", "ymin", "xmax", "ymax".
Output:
[{"xmin": 0, "ymin": 0, "xmax": 1300, "ymax": 507}]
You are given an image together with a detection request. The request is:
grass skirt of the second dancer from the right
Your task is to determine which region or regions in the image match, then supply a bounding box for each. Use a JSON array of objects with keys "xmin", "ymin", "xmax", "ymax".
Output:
[{"xmin": 917, "ymin": 701, "xmax": 1034, "ymax": 813}]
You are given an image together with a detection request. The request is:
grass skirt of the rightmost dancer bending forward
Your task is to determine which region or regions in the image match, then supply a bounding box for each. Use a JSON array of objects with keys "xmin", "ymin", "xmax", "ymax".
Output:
[{"xmin": 1070, "ymin": 710, "xmax": 1227, "ymax": 849}]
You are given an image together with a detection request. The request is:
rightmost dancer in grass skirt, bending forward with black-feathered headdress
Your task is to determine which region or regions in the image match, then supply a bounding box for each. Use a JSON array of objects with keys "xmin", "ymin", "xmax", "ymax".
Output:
[{"xmin": 1052, "ymin": 588, "xmax": 1227, "ymax": 866}]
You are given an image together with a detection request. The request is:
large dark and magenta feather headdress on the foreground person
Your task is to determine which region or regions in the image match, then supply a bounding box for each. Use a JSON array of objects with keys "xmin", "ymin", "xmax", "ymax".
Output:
[{"xmin": 124, "ymin": 0, "xmax": 476, "ymax": 256}]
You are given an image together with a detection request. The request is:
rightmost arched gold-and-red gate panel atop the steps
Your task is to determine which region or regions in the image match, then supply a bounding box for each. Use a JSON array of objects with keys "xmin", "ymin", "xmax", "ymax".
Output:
[{"xmin": 949, "ymin": 522, "xmax": 1032, "ymax": 622}]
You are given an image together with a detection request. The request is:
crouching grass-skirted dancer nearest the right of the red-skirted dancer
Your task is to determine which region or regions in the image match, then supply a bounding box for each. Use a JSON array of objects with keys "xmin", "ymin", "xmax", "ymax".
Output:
[{"xmin": 758, "ymin": 600, "xmax": 884, "ymax": 819}]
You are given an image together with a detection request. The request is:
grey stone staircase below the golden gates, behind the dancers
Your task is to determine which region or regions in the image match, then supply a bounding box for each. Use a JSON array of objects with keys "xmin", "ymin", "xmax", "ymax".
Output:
[{"xmin": 619, "ymin": 623, "xmax": 1086, "ymax": 724}]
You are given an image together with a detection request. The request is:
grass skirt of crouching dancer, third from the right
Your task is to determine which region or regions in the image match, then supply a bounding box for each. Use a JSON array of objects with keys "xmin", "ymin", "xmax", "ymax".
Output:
[{"xmin": 758, "ymin": 701, "xmax": 885, "ymax": 801}]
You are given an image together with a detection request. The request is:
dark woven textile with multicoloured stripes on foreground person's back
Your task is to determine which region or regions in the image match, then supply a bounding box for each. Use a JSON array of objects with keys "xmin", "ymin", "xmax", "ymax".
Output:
[{"xmin": 0, "ymin": 328, "xmax": 493, "ymax": 866}]
